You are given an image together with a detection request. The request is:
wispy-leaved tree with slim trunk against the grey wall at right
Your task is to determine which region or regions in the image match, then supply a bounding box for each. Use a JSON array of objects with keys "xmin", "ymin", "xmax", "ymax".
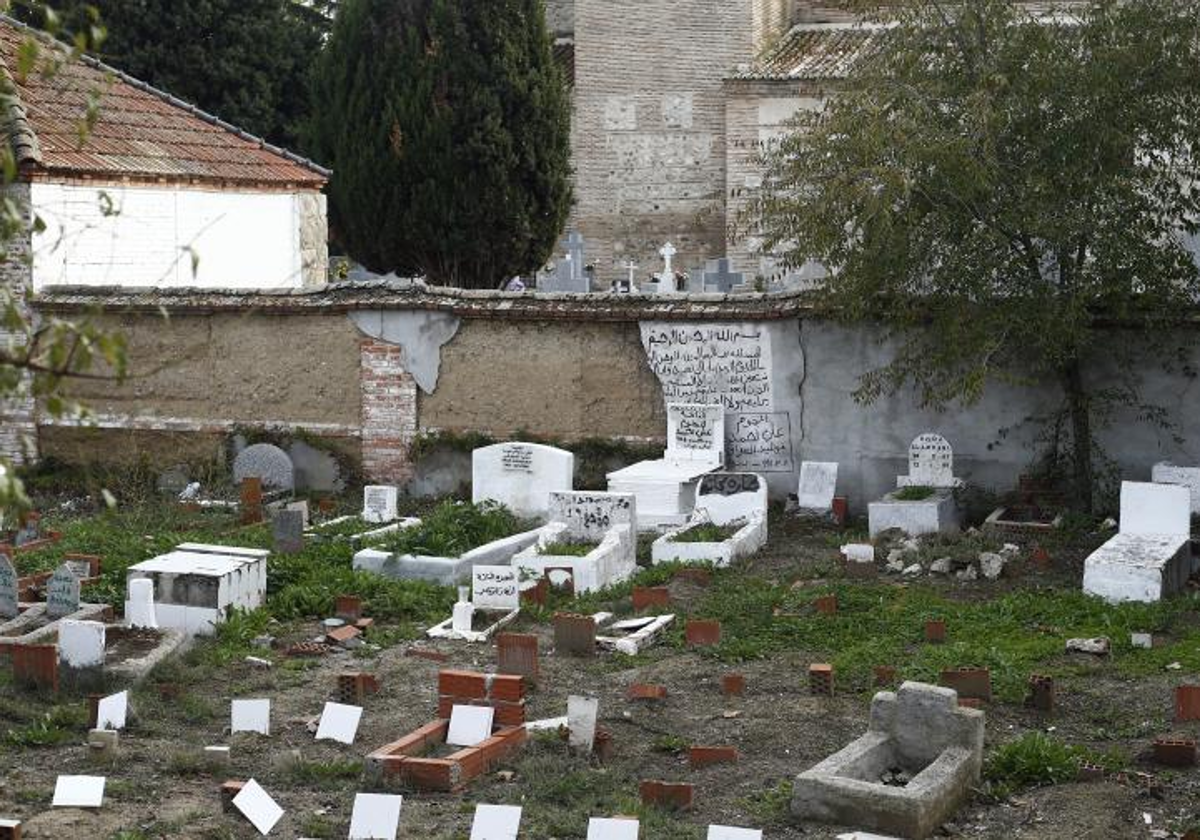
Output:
[{"xmin": 754, "ymin": 0, "xmax": 1200, "ymax": 510}]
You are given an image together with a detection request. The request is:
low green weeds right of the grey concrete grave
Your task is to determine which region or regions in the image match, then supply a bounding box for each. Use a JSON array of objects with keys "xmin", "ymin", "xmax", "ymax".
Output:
[{"xmin": 983, "ymin": 732, "xmax": 1122, "ymax": 799}]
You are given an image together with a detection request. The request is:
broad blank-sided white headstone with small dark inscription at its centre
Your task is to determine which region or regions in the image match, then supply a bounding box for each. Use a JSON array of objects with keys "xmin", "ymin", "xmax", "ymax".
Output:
[{"xmin": 470, "ymin": 443, "xmax": 575, "ymax": 520}]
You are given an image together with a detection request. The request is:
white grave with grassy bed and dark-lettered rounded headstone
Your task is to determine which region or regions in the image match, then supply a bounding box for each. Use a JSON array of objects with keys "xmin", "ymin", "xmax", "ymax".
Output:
[{"xmin": 650, "ymin": 473, "xmax": 767, "ymax": 566}]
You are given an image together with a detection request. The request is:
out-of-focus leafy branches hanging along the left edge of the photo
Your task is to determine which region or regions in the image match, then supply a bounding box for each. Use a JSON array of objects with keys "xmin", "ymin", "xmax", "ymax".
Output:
[{"xmin": 0, "ymin": 9, "xmax": 126, "ymax": 523}]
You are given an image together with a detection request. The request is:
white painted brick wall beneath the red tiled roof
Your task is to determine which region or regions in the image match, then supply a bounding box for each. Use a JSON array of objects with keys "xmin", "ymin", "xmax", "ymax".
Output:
[{"xmin": 31, "ymin": 182, "xmax": 324, "ymax": 290}]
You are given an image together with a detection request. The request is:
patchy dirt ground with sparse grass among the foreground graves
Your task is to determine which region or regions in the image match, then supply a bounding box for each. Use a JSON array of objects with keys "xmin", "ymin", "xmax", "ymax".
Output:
[{"xmin": 0, "ymin": 501, "xmax": 1200, "ymax": 840}]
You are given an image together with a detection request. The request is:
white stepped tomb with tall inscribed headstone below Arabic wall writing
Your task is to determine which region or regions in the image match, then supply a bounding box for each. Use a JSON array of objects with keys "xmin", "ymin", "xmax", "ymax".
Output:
[{"xmin": 608, "ymin": 403, "xmax": 725, "ymax": 530}]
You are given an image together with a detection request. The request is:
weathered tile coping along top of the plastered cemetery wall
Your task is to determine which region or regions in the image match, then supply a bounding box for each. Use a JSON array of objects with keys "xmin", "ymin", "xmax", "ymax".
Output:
[{"xmin": 34, "ymin": 280, "xmax": 816, "ymax": 322}]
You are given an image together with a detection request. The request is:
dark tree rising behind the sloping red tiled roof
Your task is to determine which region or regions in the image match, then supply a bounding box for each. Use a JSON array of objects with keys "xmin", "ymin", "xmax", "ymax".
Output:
[{"xmin": 17, "ymin": 0, "xmax": 334, "ymax": 148}]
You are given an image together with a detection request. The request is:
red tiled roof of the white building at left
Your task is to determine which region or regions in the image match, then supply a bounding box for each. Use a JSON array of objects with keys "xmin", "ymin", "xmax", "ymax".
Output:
[{"xmin": 0, "ymin": 16, "xmax": 329, "ymax": 188}]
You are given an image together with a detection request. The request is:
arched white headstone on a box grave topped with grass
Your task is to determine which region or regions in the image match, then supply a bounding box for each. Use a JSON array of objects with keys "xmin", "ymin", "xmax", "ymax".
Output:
[{"xmin": 868, "ymin": 432, "xmax": 962, "ymax": 536}]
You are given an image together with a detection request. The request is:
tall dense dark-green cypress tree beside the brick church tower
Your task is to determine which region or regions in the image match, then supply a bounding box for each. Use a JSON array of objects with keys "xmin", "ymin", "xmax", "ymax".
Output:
[{"xmin": 312, "ymin": 0, "xmax": 571, "ymax": 288}]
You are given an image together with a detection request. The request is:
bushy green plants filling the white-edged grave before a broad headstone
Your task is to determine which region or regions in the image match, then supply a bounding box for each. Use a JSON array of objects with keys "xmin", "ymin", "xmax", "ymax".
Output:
[{"xmin": 379, "ymin": 502, "xmax": 534, "ymax": 557}]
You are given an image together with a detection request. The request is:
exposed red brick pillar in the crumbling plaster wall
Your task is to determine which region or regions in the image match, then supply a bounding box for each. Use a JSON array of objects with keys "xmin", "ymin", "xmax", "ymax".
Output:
[{"xmin": 359, "ymin": 338, "xmax": 416, "ymax": 485}]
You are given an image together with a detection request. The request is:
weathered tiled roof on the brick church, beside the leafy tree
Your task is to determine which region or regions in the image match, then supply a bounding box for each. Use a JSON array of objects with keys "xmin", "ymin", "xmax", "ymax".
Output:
[{"xmin": 733, "ymin": 24, "xmax": 887, "ymax": 80}]
